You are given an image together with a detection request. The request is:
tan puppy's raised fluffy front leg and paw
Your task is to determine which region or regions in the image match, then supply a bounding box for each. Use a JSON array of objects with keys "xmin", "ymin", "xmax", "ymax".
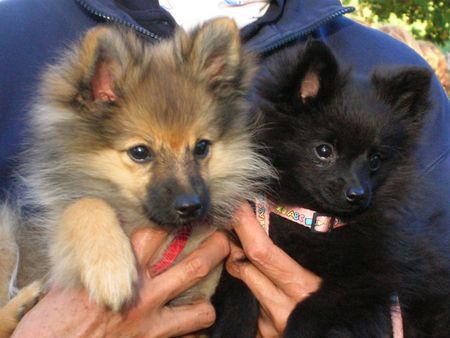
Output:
[{"xmin": 50, "ymin": 198, "xmax": 137, "ymax": 311}]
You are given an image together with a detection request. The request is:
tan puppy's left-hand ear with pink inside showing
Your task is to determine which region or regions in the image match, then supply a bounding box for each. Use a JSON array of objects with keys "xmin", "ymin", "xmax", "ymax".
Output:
[{"xmin": 42, "ymin": 26, "xmax": 136, "ymax": 114}]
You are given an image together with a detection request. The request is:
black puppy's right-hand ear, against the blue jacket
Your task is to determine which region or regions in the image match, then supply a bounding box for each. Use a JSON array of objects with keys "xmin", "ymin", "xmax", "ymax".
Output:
[{"xmin": 372, "ymin": 67, "xmax": 432, "ymax": 122}]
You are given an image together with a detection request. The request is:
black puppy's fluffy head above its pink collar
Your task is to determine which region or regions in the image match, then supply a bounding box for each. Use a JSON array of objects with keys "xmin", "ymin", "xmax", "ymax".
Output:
[{"xmin": 257, "ymin": 41, "xmax": 431, "ymax": 215}]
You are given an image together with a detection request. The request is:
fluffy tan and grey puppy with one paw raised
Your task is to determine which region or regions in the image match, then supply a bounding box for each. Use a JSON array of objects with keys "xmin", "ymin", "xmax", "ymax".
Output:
[{"xmin": 0, "ymin": 19, "xmax": 273, "ymax": 332}]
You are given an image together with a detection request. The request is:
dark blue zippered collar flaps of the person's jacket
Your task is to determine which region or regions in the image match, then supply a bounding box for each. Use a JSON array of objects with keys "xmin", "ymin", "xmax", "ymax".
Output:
[{"xmin": 74, "ymin": 0, "xmax": 354, "ymax": 53}]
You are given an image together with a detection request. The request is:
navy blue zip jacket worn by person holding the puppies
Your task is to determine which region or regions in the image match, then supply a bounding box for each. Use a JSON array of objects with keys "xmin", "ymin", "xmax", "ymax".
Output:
[{"xmin": 0, "ymin": 0, "xmax": 450, "ymax": 228}]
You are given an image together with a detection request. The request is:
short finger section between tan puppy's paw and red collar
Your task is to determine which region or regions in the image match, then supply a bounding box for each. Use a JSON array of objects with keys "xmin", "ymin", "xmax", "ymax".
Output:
[{"xmin": 131, "ymin": 228, "xmax": 167, "ymax": 270}]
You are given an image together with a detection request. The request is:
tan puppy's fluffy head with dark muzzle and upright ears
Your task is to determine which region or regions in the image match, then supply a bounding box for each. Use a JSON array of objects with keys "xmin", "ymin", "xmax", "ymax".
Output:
[{"xmin": 36, "ymin": 19, "xmax": 271, "ymax": 230}]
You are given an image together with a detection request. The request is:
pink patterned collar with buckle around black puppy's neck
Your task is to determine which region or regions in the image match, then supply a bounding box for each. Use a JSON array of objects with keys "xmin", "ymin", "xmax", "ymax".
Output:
[{"xmin": 255, "ymin": 194, "xmax": 345, "ymax": 233}]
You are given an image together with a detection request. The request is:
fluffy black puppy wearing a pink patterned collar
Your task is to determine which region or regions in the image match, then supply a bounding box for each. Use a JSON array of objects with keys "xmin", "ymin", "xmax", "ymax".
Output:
[{"xmin": 213, "ymin": 41, "xmax": 450, "ymax": 338}]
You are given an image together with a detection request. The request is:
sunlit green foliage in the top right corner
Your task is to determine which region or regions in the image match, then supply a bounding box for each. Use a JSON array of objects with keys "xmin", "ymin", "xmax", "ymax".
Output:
[{"xmin": 343, "ymin": 0, "xmax": 450, "ymax": 45}]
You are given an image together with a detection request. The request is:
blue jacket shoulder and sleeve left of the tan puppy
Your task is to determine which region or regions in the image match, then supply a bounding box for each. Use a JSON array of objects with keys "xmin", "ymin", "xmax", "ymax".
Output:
[{"xmin": 0, "ymin": 0, "xmax": 95, "ymax": 199}]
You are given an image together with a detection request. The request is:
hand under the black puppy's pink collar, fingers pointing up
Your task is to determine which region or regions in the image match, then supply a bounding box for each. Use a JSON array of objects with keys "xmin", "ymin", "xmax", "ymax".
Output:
[{"xmin": 226, "ymin": 204, "xmax": 321, "ymax": 338}]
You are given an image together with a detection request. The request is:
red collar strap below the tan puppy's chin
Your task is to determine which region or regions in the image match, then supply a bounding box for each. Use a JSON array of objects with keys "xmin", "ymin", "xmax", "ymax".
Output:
[{"xmin": 151, "ymin": 226, "xmax": 192, "ymax": 276}]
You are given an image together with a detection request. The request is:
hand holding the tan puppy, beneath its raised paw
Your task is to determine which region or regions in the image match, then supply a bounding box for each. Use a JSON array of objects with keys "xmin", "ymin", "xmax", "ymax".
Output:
[{"xmin": 12, "ymin": 229, "xmax": 229, "ymax": 338}]
